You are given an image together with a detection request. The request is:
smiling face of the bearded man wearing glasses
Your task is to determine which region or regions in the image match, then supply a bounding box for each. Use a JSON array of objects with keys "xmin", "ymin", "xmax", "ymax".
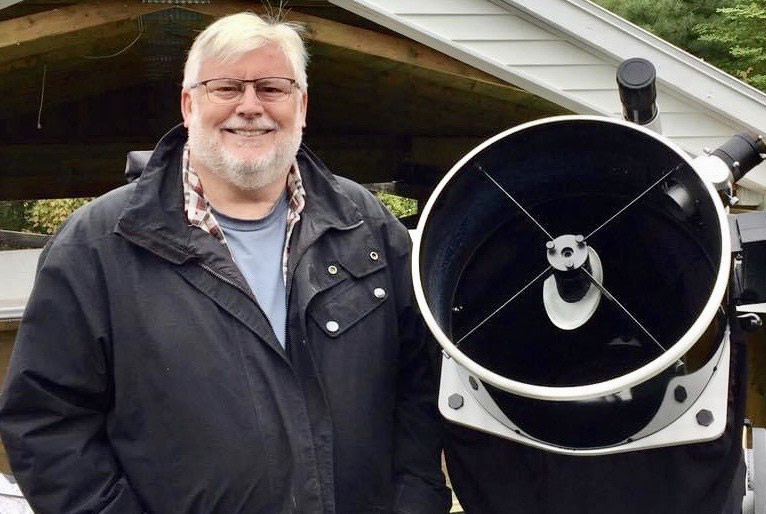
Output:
[{"xmin": 181, "ymin": 44, "xmax": 308, "ymax": 190}]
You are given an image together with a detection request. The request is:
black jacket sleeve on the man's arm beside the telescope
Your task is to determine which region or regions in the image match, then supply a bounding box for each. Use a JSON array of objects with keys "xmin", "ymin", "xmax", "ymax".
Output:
[{"xmin": 389, "ymin": 222, "xmax": 452, "ymax": 514}]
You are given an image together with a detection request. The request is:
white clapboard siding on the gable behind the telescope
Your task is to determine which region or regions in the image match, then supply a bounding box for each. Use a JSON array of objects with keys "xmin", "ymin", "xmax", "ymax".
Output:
[{"xmin": 330, "ymin": 0, "xmax": 766, "ymax": 188}]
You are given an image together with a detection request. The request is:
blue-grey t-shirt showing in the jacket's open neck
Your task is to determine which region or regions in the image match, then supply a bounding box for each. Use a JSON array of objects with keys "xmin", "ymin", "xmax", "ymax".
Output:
[{"xmin": 213, "ymin": 192, "xmax": 287, "ymax": 348}]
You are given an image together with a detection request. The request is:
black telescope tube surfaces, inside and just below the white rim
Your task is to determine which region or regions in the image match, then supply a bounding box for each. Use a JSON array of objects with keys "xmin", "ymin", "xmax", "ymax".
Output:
[{"xmin": 420, "ymin": 119, "xmax": 721, "ymax": 446}]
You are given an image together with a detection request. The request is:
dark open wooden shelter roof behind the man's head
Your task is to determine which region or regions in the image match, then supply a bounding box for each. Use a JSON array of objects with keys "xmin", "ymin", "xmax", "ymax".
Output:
[{"xmin": 0, "ymin": 0, "xmax": 565, "ymax": 199}]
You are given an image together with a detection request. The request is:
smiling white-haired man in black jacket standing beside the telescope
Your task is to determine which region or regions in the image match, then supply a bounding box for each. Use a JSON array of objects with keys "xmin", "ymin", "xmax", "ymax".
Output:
[{"xmin": 0, "ymin": 13, "xmax": 448, "ymax": 514}]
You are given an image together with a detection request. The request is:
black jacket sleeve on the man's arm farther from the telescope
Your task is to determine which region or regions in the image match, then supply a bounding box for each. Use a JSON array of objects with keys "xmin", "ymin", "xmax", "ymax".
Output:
[{"xmin": 0, "ymin": 243, "xmax": 143, "ymax": 514}]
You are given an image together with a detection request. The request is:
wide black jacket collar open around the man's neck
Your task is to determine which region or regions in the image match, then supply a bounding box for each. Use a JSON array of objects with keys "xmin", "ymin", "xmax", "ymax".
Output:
[{"xmin": 115, "ymin": 125, "xmax": 362, "ymax": 264}]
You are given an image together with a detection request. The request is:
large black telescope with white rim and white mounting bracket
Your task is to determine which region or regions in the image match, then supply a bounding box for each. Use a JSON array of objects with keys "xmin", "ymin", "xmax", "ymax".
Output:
[{"xmin": 412, "ymin": 59, "xmax": 766, "ymax": 513}]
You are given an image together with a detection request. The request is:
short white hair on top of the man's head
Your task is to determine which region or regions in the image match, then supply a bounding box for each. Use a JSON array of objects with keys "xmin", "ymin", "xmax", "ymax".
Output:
[{"xmin": 183, "ymin": 12, "xmax": 308, "ymax": 91}]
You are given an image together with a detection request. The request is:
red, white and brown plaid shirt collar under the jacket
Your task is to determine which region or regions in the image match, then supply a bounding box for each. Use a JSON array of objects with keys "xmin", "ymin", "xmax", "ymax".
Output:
[{"xmin": 181, "ymin": 143, "xmax": 306, "ymax": 283}]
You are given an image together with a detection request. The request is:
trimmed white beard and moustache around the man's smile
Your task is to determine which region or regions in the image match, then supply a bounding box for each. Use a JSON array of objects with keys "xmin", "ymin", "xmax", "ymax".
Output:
[{"xmin": 189, "ymin": 109, "xmax": 303, "ymax": 191}]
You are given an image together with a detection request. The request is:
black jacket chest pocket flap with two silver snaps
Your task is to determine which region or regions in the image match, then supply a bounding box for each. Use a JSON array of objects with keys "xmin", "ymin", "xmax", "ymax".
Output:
[{"xmin": 309, "ymin": 277, "xmax": 388, "ymax": 338}]
